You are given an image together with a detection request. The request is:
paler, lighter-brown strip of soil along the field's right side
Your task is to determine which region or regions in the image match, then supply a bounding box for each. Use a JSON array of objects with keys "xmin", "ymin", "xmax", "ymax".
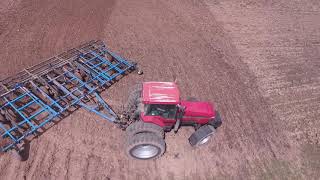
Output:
[{"xmin": 206, "ymin": 0, "xmax": 320, "ymax": 179}]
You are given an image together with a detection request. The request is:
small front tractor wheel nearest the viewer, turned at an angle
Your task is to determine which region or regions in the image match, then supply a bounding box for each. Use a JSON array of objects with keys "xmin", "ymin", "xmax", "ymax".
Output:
[{"xmin": 189, "ymin": 125, "xmax": 215, "ymax": 147}]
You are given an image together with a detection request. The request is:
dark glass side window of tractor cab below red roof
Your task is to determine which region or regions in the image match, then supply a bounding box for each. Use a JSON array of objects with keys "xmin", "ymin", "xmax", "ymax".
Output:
[{"xmin": 144, "ymin": 104, "xmax": 177, "ymax": 119}]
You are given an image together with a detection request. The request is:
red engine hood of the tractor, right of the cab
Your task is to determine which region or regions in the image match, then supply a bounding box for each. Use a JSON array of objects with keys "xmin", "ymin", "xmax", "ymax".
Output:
[{"xmin": 181, "ymin": 101, "xmax": 215, "ymax": 118}]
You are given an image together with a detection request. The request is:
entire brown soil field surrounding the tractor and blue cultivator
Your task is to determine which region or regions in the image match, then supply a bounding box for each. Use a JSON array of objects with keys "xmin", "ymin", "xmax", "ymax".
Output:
[{"xmin": 0, "ymin": 0, "xmax": 320, "ymax": 179}]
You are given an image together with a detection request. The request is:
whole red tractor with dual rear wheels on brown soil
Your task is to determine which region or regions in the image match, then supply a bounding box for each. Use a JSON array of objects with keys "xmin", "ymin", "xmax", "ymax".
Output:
[{"xmin": 122, "ymin": 82, "xmax": 222, "ymax": 159}]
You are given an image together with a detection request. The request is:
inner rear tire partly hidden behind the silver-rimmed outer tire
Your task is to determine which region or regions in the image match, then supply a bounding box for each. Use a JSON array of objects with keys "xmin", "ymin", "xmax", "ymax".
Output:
[{"xmin": 126, "ymin": 121, "xmax": 164, "ymax": 139}]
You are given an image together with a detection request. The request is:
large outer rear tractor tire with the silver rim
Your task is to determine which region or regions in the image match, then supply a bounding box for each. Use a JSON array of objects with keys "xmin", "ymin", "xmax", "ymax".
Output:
[{"xmin": 126, "ymin": 133, "xmax": 166, "ymax": 160}]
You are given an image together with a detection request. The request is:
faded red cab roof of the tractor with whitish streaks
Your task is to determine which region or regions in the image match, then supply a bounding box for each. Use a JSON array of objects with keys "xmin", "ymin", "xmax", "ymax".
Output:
[{"xmin": 142, "ymin": 82, "xmax": 180, "ymax": 104}]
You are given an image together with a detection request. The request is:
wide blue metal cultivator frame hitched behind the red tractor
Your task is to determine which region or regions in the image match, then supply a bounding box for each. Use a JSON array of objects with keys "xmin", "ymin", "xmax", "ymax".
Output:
[{"xmin": 0, "ymin": 41, "xmax": 136, "ymax": 151}]
